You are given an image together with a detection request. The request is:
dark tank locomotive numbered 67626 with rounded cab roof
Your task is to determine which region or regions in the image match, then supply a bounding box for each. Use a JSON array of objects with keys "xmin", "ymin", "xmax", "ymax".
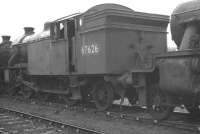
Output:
[{"xmin": 0, "ymin": 4, "xmax": 169, "ymax": 110}]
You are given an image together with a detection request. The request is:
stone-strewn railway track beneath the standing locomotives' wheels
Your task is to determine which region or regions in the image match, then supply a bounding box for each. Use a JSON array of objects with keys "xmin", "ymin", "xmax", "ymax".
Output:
[{"xmin": 61, "ymin": 100, "xmax": 200, "ymax": 133}]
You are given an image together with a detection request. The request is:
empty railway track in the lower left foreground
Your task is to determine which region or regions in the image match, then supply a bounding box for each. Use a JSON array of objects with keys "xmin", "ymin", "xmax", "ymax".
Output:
[{"xmin": 0, "ymin": 107, "xmax": 104, "ymax": 134}]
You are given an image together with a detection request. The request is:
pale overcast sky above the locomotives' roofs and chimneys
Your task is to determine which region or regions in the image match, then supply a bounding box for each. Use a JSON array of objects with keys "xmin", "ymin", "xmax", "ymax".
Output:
[{"xmin": 0, "ymin": 0, "xmax": 191, "ymax": 48}]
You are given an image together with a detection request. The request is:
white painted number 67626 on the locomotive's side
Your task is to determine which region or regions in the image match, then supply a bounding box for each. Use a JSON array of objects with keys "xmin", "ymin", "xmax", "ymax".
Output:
[{"xmin": 81, "ymin": 44, "xmax": 99, "ymax": 55}]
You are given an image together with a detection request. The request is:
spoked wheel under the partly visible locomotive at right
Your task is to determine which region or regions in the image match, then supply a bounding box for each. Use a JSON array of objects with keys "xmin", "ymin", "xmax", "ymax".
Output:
[{"xmin": 148, "ymin": 85, "xmax": 174, "ymax": 120}]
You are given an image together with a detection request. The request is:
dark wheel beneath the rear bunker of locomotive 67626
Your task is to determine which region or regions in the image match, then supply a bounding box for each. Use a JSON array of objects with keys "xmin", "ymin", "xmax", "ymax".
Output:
[{"xmin": 93, "ymin": 81, "xmax": 114, "ymax": 111}]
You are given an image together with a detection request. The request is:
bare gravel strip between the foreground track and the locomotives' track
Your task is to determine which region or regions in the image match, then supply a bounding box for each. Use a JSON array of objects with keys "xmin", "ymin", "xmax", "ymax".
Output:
[{"xmin": 0, "ymin": 98, "xmax": 198, "ymax": 134}]
